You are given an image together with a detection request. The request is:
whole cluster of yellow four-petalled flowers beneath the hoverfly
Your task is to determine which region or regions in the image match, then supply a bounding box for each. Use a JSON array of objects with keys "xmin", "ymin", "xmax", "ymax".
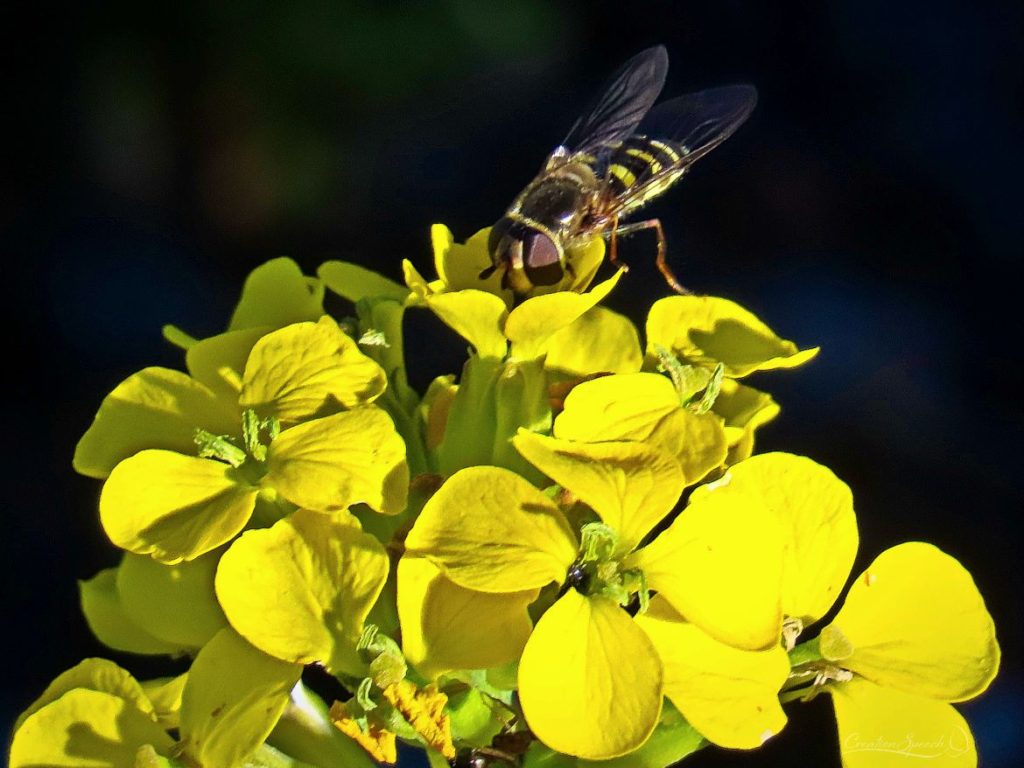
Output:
[{"xmin": 9, "ymin": 226, "xmax": 999, "ymax": 768}]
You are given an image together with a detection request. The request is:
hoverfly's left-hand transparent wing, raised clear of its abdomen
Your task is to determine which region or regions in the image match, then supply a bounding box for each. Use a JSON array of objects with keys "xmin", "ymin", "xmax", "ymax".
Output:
[{"xmin": 562, "ymin": 45, "xmax": 669, "ymax": 154}]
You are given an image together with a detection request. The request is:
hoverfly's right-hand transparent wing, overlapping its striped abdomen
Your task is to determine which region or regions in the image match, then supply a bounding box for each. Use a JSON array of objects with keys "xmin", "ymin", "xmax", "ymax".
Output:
[{"xmin": 610, "ymin": 85, "xmax": 758, "ymax": 213}]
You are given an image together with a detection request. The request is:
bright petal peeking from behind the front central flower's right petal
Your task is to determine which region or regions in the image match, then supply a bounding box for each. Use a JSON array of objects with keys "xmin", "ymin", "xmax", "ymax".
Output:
[{"xmin": 692, "ymin": 453, "xmax": 858, "ymax": 625}]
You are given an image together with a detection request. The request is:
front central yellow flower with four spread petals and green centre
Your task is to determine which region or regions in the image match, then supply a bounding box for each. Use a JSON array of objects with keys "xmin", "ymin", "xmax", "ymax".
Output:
[{"xmin": 398, "ymin": 433, "xmax": 784, "ymax": 759}]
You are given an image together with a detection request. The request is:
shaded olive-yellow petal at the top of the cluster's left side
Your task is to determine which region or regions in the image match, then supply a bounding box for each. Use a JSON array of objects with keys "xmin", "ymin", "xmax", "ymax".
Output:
[{"xmin": 228, "ymin": 257, "xmax": 324, "ymax": 331}]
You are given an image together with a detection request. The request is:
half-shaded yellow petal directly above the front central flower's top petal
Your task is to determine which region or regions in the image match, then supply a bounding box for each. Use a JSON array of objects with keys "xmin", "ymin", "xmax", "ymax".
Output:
[{"xmin": 554, "ymin": 374, "xmax": 728, "ymax": 484}]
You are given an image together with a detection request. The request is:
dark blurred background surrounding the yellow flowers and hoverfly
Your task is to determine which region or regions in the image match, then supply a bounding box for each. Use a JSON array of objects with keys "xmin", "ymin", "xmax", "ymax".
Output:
[{"xmin": 0, "ymin": 0, "xmax": 1024, "ymax": 766}]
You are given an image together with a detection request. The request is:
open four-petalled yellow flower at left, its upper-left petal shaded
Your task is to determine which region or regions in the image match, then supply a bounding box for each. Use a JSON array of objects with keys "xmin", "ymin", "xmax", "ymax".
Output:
[{"xmin": 89, "ymin": 317, "xmax": 409, "ymax": 563}]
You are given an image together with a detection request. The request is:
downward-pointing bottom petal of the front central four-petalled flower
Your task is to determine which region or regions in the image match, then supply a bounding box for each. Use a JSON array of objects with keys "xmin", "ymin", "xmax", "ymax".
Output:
[{"xmin": 519, "ymin": 590, "xmax": 662, "ymax": 760}]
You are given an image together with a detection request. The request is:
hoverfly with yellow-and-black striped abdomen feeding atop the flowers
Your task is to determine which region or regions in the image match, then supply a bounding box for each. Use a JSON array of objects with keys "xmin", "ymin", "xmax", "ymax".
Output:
[{"xmin": 480, "ymin": 45, "xmax": 757, "ymax": 296}]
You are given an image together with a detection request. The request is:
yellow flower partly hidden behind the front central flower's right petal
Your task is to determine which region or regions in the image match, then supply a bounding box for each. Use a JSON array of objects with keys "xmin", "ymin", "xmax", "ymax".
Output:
[{"xmin": 637, "ymin": 454, "xmax": 857, "ymax": 750}]
